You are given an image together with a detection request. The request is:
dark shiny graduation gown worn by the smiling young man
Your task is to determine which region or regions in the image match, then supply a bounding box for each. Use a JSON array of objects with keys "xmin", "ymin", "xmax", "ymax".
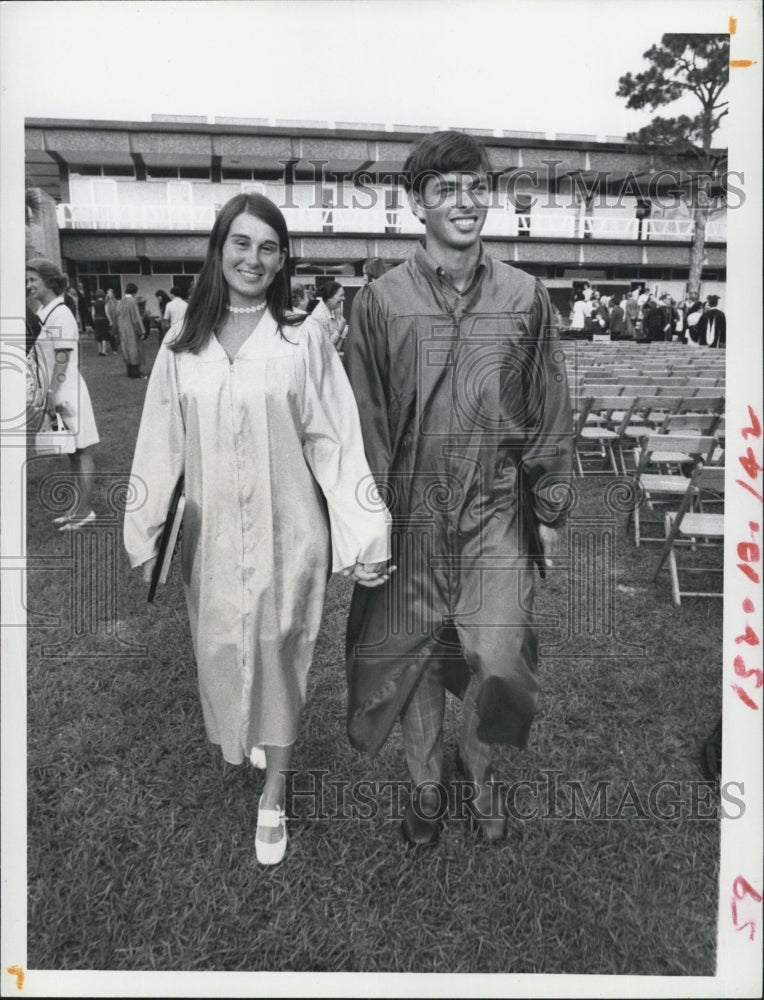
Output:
[{"xmin": 345, "ymin": 246, "xmax": 572, "ymax": 753}]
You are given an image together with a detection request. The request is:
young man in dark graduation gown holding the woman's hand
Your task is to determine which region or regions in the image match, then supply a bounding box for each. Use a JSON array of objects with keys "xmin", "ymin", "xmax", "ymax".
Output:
[{"xmin": 345, "ymin": 132, "xmax": 572, "ymax": 846}]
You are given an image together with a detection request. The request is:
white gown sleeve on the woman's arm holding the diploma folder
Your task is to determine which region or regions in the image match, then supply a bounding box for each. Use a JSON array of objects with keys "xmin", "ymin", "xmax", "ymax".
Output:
[{"xmin": 124, "ymin": 335, "xmax": 186, "ymax": 567}]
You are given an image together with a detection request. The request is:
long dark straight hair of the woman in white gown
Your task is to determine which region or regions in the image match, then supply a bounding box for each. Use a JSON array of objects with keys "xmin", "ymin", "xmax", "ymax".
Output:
[{"xmin": 170, "ymin": 194, "xmax": 304, "ymax": 353}]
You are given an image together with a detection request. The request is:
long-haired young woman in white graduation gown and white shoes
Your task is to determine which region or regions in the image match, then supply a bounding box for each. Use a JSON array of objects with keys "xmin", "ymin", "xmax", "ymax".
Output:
[{"xmin": 125, "ymin": 194, "xmax": 392, "ymax": 864}]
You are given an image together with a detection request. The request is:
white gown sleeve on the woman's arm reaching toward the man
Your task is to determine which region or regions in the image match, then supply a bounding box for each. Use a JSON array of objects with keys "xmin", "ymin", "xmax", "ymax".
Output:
[{"xmin": 301, "ymin": 317, "xmax": 390, "ymax": 573}]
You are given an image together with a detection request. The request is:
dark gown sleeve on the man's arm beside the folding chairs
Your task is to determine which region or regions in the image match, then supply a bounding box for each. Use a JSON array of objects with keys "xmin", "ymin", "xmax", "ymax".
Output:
[{"xmin": 522, "ymin": 281, "xmax": 573, "ymax": 527}]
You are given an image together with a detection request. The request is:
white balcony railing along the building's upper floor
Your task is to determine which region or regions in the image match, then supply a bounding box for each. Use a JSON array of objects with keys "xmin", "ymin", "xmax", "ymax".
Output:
[{"xmin": 57, "ymin": 204, "xmax": 727, "ymax": 242}]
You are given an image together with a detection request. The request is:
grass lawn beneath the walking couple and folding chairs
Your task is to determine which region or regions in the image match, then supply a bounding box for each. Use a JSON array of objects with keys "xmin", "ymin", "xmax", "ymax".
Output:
[{"xmin": 22, "ymin": 336, "xmax": 722, "ymax": 976}]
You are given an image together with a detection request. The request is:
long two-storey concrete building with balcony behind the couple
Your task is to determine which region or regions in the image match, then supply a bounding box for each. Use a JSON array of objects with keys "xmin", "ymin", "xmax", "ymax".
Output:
[{"xmin": 26, "ymin": 115, "xmax": 726, "ymax": 316}]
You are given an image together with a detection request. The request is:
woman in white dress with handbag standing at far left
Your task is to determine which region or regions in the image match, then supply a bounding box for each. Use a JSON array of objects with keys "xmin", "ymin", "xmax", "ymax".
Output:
[{"xmin": 26, "ymin": 257, "xmax": 99, "ymax": 531}]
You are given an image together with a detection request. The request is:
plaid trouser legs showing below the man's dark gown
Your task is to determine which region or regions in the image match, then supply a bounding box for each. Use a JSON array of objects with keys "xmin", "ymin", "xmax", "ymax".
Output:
[{"xmin": 400, "ymin": 670, "xmax": 493, "ymax": 785}]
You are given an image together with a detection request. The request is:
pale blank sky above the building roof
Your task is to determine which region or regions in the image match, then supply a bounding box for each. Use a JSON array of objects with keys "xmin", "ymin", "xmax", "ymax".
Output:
[{"xmin": 0, "ymin": 0, "xmax": 753, "ymax": 145}]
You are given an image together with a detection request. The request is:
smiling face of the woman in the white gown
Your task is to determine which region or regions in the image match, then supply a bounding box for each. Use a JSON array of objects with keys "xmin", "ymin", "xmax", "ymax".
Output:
[{"xmin": 221, "ymin": 212, "xmax": 286, "ymax": 307}]
